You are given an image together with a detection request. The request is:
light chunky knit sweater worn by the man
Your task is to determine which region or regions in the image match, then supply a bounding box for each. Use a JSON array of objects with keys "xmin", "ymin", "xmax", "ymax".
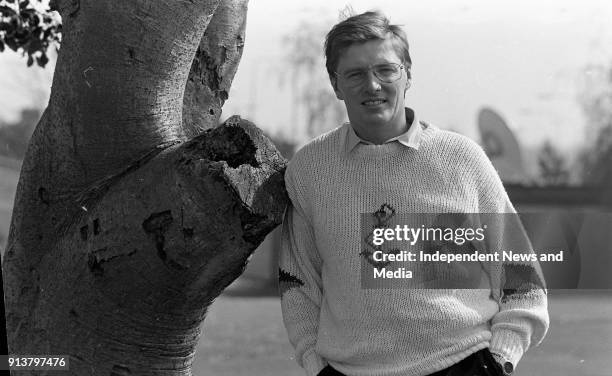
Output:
[{"xmin": 279, "ymin": 121, "xmax": 549, "ymax": 376}]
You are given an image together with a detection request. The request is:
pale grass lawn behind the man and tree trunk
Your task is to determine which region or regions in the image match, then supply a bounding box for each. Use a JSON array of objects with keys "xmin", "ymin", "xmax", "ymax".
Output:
[{"xmin": 194, "ymin": 291, "xmax": 612, "ymax": 376}]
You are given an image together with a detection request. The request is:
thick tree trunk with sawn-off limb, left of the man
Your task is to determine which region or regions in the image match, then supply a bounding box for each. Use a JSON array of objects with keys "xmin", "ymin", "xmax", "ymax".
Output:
[{"xmin": 3, "ymin": 0, "xmax": 286, "ymax": 375}]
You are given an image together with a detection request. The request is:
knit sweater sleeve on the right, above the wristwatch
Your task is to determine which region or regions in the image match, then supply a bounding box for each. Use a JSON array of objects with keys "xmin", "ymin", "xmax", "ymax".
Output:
[{"xmin": 468, "ymin": 142, "xmax": 549, "ymax": 367}]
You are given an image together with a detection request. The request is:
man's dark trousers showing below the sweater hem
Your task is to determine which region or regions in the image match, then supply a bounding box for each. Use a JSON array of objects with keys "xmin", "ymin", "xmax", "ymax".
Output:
[{"xmin": 318, "ymin": 349, "xmax": 503, "ymax": 376}]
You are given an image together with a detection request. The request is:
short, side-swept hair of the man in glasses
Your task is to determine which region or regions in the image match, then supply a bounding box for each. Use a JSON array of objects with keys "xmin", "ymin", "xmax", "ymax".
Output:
[{"xmin": 325, "ymin": 11, "xmax": 412, "ymax": 78}]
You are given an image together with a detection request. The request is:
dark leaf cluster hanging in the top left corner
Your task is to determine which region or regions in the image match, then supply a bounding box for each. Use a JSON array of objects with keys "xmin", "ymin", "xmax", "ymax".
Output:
[{"xmin": 0, "ymin": 0, "xmax": 62, "ymax": 67}]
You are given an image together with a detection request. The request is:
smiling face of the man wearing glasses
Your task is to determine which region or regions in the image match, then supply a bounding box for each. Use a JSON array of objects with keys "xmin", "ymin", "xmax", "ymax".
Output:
[{"xmin": 332, "ymin": 39, "xmax": 409, "ymax": 142}]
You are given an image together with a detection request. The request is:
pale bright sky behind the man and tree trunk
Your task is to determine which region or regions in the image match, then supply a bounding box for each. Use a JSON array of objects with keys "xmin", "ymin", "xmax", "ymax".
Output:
[{"xmin": 0, "ymin": 0, "xmax": 612, "ymax": 156}]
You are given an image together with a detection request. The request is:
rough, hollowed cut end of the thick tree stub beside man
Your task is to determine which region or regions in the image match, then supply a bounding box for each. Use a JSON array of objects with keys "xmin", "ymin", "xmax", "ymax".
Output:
[{"xmin": 179, "ymin": 116, "xmax": 287, "ymax": 244}]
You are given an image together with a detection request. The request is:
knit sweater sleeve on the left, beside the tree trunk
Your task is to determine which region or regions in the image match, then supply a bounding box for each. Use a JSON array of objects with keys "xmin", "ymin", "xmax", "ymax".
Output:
[{"xmin": 279, "ymin": 165, "xmax": 327, "ymax": 376}]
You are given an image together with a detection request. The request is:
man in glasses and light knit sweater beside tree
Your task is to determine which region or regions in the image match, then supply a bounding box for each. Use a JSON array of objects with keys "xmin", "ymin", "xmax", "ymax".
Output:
[{"xmin": 279, "ymin": 12, "xmax": 548, "ymax": 376}]
